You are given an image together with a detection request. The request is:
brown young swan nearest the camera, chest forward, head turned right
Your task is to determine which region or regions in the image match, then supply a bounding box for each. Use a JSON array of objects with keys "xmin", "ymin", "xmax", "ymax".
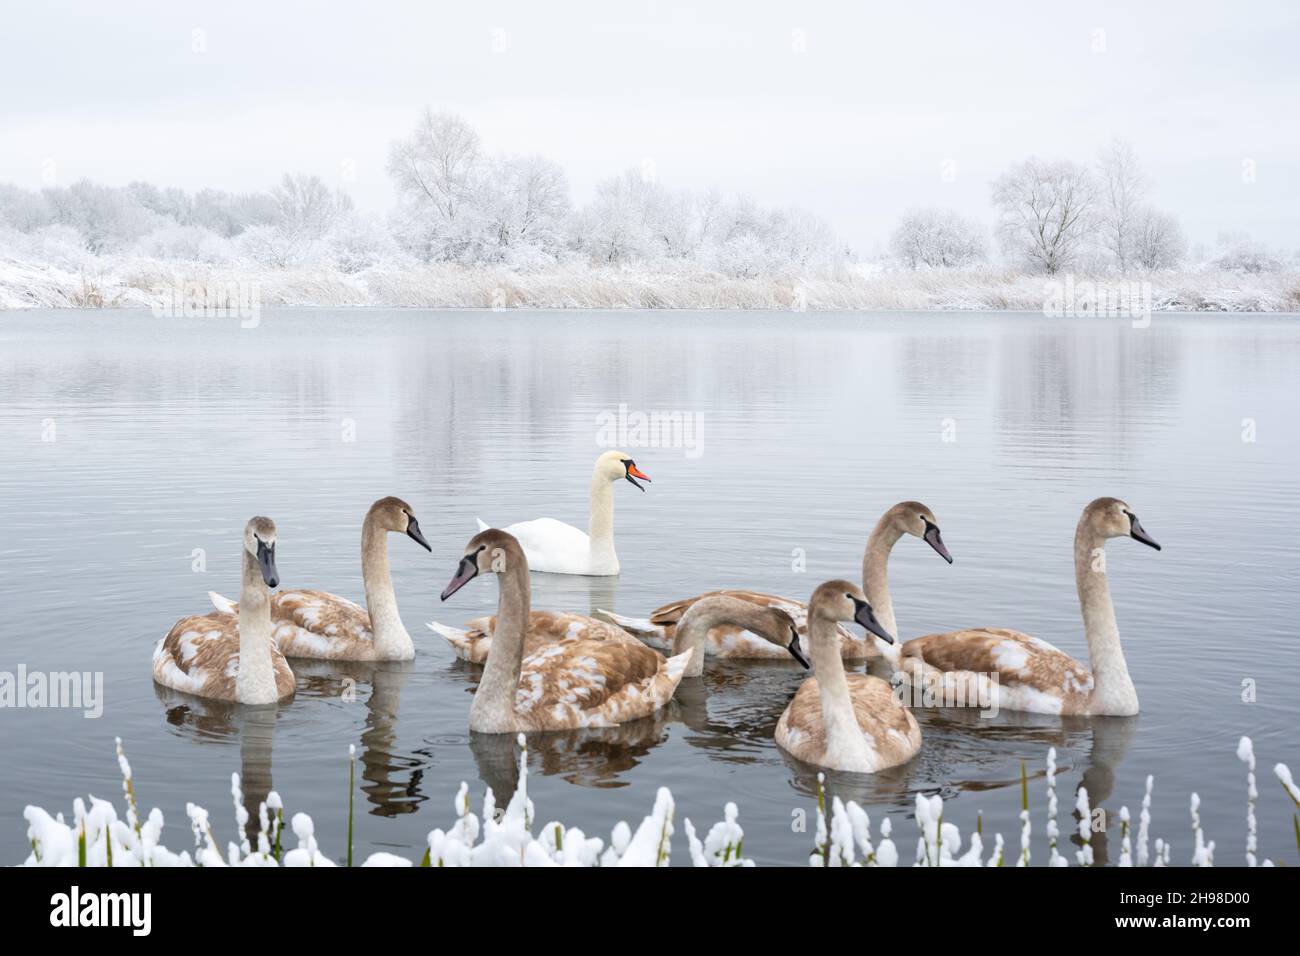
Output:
[{"xmin": 776, "ymin": 581, "xmax": 920, "ymax": 774}]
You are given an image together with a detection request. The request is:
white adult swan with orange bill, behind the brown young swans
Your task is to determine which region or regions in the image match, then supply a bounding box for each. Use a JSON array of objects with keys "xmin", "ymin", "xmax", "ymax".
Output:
[{"xmin": 478, "ymin": 451, "xmax": 650, "ymax": 575}]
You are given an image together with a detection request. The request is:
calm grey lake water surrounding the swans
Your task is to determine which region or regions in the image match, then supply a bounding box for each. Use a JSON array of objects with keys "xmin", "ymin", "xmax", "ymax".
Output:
[{"xmin": 0, "ymin": 310, "xmax": 1300, "ymax": 864}]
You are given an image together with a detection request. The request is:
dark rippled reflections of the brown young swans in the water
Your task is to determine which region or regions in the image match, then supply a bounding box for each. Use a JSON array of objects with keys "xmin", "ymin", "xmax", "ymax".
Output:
[{"xmin": 155, "ymin": 624, "xmax": 1139, "ymax": 865}]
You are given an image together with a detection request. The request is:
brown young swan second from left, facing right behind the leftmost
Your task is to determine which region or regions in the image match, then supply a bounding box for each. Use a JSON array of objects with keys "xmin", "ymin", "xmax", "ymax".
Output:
[{"xmin": 209, "ymin": 497, "xmax": 433, "ymax": 661}]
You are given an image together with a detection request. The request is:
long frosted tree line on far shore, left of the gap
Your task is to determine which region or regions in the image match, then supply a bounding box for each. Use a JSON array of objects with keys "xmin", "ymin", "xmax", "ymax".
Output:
[{"xmin": 0, "ymin": 111, "xmax": 848, "ymax": 277}]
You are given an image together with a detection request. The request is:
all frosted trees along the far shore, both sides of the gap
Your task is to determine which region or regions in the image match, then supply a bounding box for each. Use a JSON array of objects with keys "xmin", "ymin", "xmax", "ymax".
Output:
[{"xmin": 0, "ymin": 109, "xmax": 1287, "ymax": 278}]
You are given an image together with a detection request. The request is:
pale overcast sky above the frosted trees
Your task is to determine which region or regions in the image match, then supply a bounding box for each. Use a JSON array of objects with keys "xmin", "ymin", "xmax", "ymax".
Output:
[{"xmin": 0, "ymin": 0, "xmax": 1300, "ymax": 252}]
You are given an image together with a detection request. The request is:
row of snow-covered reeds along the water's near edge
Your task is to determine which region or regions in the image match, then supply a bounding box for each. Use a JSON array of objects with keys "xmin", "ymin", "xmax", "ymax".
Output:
[{"xmin": 15, "ymin": 735, "xmax": 1300, "ymax": 868}]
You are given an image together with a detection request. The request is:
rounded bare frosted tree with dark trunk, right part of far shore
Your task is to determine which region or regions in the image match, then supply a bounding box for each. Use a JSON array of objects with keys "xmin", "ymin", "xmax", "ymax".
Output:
[{"xmin": 993, "ymin": 159, "xmax": 1097, "ymax": 274}]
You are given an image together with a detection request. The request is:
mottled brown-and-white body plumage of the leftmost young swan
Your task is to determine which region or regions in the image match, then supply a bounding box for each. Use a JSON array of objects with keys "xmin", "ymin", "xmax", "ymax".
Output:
[{"xmin": 153, "ymin": 611, "xmax": 296, "ymax": 701}]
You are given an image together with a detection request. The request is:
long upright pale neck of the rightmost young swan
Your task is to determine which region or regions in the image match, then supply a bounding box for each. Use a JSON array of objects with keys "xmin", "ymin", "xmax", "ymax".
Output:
[{"xmin": 1074, "ymin": 520, "xmax": 1138, "ymax": 717}]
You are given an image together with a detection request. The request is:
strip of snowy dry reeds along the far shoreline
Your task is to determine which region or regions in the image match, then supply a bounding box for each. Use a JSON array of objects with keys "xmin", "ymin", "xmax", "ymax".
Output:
[{"xmin": 0, "ymin": 258, "xmax": 1300, "ymax": 315}]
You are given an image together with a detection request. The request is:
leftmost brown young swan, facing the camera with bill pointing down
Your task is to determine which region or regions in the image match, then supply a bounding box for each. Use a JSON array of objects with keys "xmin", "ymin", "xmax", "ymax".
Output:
[{"xmin": 153, "ymin": 518, "xmax": 296, "ymax": 704}]
